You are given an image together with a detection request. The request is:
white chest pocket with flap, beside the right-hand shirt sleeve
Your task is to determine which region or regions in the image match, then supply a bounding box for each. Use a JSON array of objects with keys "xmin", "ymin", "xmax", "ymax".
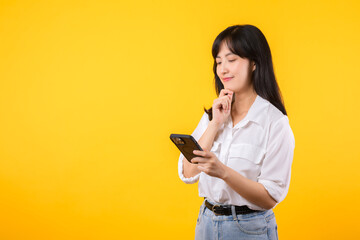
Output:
[{"xmin": 227, "ymin": 143, "xmax": 266, "ymax": 180}]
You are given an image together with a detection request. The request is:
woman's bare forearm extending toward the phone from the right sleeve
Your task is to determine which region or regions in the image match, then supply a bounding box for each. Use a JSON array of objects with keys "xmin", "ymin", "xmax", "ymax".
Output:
[{"xmin": 222, "ymin": 166, "xmax": 276, "ymax": 209}]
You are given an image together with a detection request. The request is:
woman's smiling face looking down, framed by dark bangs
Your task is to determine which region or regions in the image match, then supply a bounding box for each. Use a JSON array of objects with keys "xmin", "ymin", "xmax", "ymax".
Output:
[{"xmin": 216, "ymin": 41, "xmax": 255, "ymax": 92}]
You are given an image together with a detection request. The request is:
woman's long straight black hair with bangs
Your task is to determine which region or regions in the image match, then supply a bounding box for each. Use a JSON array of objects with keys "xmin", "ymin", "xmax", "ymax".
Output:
[{"xmin": 204, "ymin": 25, "xmax": 287, "ymax": 120}]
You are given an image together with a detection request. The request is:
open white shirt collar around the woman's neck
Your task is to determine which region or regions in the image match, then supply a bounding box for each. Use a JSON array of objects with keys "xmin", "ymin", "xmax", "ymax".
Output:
[{"xmin": 225, "ymin": 95, "xmax": 270, "ymax": 128}]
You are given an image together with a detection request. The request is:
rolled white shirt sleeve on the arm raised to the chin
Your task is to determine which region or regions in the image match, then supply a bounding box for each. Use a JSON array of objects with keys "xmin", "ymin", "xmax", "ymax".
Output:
[{"xmin": 178, "ymin": 113, "xmax": 209, "ymax": 184}]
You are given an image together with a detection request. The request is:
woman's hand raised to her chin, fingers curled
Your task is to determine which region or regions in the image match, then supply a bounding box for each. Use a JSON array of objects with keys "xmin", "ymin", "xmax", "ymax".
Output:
[{"xmin": 211, "ymin": 89, "xmax": 234, "ymax": 125}]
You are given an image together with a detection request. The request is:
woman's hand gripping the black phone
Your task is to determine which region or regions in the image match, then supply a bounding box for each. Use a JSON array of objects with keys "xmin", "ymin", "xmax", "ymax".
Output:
[{"xmin": 191, "ymin": 149, "xmax": 226, "ymax": 179}]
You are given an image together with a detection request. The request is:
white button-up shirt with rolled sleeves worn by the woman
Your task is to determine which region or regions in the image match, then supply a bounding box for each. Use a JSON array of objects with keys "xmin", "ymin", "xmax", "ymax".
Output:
[{"xmin": 178, "ymin": 95, "xmax": 295, "ymax": 210}]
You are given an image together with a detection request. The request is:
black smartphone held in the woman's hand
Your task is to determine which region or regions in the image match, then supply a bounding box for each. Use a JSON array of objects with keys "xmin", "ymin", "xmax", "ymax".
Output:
[{"xmin": 170, "ymin": 134, "xmax": 203, "ymax": 163}]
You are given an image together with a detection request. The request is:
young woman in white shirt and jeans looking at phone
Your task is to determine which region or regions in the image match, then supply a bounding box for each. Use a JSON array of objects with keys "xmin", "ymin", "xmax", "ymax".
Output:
[{"xmin": 178, "ymin": 25, "xmax": 295, "ymax": 240}]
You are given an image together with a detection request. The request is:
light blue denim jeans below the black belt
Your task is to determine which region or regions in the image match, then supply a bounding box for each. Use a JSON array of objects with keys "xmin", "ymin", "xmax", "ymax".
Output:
[{"xmin": 195, "ymin": 202, "xmax": 278, "ymax": 240}]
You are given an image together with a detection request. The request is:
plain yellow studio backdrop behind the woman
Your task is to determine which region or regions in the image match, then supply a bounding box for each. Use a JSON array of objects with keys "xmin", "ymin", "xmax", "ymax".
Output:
[{"xmin": 0, "ymin": 0, "xmax": 360, "ymax": 240}]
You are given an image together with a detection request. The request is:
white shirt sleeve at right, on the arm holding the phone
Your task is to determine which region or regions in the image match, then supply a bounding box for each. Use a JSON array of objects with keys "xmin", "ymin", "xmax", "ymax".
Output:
[{"xmin": 258, "ymin": 116, "xmax": 295, "ymax": 204}]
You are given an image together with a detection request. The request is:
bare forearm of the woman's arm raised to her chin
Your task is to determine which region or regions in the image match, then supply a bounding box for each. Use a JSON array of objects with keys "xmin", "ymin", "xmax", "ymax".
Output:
[{"xmin": 183, "ymin": 121, "xmax": 220, "ymax": 178}]
